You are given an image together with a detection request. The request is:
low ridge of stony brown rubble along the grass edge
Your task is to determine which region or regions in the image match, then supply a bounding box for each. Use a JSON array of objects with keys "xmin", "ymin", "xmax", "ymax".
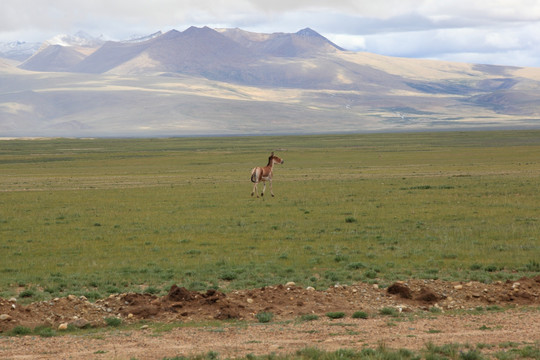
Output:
[{"xmin": 0, "ymin": 276, "xmax": 540, "ymax": 332}]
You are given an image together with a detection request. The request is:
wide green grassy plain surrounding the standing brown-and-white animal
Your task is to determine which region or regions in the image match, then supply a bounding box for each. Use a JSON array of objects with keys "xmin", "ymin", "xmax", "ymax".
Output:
[{"xmin": 0, "ymin": 131, "xmax": 540, "ymax": 299}]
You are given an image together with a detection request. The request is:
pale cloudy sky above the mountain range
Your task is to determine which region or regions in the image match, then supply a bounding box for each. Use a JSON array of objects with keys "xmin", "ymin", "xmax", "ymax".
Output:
[{"xmin": 0, "ymin": 0, "xmax": 540, "ymax": 67}]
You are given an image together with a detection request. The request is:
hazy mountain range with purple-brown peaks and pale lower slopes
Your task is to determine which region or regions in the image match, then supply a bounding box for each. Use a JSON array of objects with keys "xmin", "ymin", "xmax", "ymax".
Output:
[{"xmin": 0, "ymin": 27, "xmax": 540, "ymax": 136}]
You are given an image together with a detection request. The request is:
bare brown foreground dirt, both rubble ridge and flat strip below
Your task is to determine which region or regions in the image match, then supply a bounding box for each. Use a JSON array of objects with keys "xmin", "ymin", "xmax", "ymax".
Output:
[{"xmin": 0, "ymin": 276, "xmax": 540, "ymax": 359}]
